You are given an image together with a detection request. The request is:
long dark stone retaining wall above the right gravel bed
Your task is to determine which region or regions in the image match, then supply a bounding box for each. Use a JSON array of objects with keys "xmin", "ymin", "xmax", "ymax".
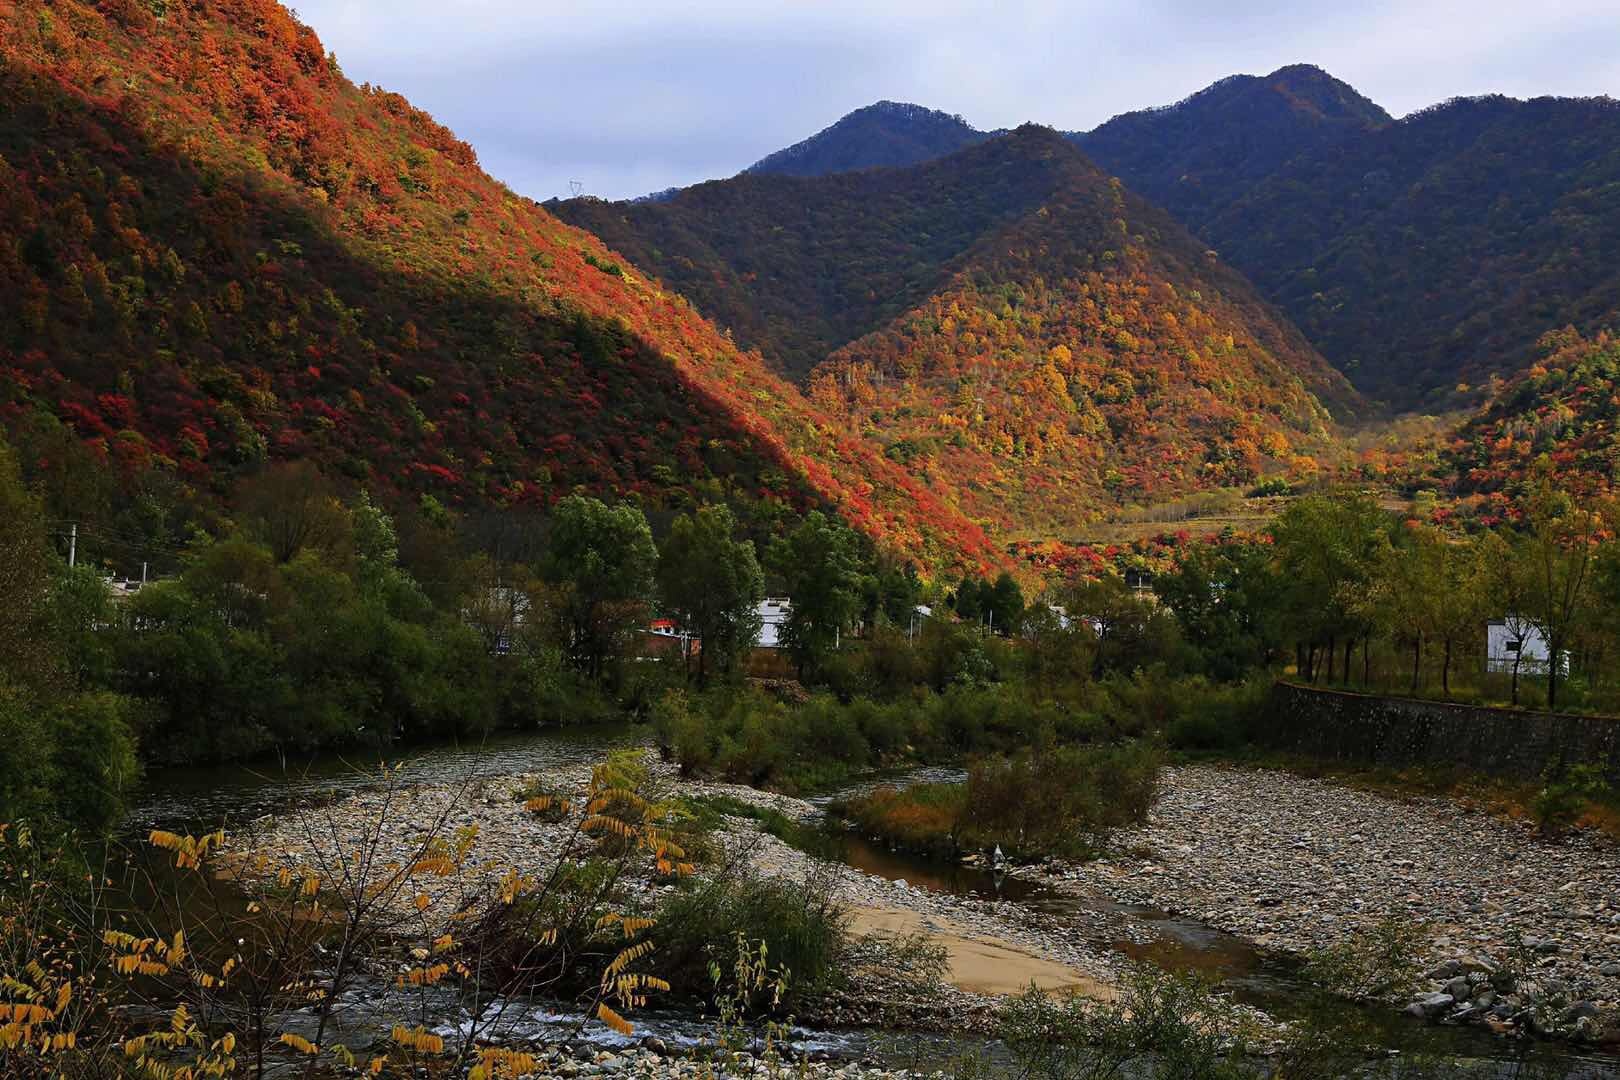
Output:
[{"xmin": 1256, "ymin": 683, "xmax": 1620, "ymax": 784}]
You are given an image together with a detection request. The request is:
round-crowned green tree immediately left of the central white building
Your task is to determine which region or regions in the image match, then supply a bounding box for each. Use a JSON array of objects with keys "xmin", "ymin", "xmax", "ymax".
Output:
[{"xmin": 658, "ymin": 505, "xmax": 765, "ymax": 685}]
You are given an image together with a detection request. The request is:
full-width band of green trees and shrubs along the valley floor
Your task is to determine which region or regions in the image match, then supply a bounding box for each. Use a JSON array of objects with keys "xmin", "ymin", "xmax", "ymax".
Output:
[{"xmin": 12, "ymin": 388, "xmax": 1620, "ymax": 831}]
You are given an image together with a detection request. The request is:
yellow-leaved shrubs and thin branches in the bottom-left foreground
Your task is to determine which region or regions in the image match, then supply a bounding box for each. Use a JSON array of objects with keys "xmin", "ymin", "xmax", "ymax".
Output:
[{"xmin": 0, "ymin": 756, "xmax": 692, "ymax": 1080}]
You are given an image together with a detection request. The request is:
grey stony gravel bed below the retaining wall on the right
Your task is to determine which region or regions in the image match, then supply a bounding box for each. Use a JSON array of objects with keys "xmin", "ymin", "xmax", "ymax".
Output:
[{"xmin": 1021, "ymin": 766, "xmax": 1620, "ymax": 1041}]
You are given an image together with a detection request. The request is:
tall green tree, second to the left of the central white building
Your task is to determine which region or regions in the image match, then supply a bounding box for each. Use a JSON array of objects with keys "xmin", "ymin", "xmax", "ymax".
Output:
[{"xmin": 541, "ymin": 495, "xmax": 658, "ymax": 678}]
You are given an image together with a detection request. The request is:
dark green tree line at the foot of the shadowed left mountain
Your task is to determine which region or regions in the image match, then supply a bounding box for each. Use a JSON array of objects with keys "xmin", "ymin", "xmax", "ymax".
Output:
[{"xmin": 0, "ymin": 430, "xmax": 991, "ymax": 829}]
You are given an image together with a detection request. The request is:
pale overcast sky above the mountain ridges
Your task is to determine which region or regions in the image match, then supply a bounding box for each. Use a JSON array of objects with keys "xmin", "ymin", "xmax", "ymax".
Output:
[{"xmin": 298, "ymin": 0, "xmax": 1620, "ymax": 199}]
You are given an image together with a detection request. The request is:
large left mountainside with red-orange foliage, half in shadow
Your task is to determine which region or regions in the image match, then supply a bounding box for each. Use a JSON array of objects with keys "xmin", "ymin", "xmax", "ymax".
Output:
[{"xmin": 0, "ymin": 0, "xmax": 993, "ymax": 563}]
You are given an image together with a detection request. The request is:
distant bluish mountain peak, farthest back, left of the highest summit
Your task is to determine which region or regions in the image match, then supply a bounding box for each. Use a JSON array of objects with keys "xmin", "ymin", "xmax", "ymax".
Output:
[{"xmin": 744, "ymin": 99, "xmax": 990, "ymax": 176}]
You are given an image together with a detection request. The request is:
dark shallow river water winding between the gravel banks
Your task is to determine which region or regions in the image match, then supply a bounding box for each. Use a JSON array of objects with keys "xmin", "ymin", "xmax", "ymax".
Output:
[{"xmin": 128, "ymin": 725, "xmax": 1620, "ymax": 1080}]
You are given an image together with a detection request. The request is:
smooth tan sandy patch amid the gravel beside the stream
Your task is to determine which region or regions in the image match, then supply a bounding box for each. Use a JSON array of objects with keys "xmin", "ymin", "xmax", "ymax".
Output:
[{"xmin": 851, "ymin": 907, "xmax": 1115, "ymax": 1001}]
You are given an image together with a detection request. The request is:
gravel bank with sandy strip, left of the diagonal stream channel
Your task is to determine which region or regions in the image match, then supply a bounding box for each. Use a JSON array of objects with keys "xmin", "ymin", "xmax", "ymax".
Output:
[{"xmin": 233, "ymin": 755, "xmax": 1124, "ymax": 1031}]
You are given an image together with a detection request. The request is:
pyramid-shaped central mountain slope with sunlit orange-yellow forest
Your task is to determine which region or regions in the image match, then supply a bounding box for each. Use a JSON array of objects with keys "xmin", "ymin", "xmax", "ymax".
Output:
[{"xmin": 812, "ymin": 128, "xmax": 1358, "ymax": 533}]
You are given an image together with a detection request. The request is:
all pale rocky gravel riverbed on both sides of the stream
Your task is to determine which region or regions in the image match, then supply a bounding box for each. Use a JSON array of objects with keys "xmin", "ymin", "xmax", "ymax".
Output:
[{"xmin": 243, "ymin": 756, "xmax": 1620, "ymax": 1041}]
